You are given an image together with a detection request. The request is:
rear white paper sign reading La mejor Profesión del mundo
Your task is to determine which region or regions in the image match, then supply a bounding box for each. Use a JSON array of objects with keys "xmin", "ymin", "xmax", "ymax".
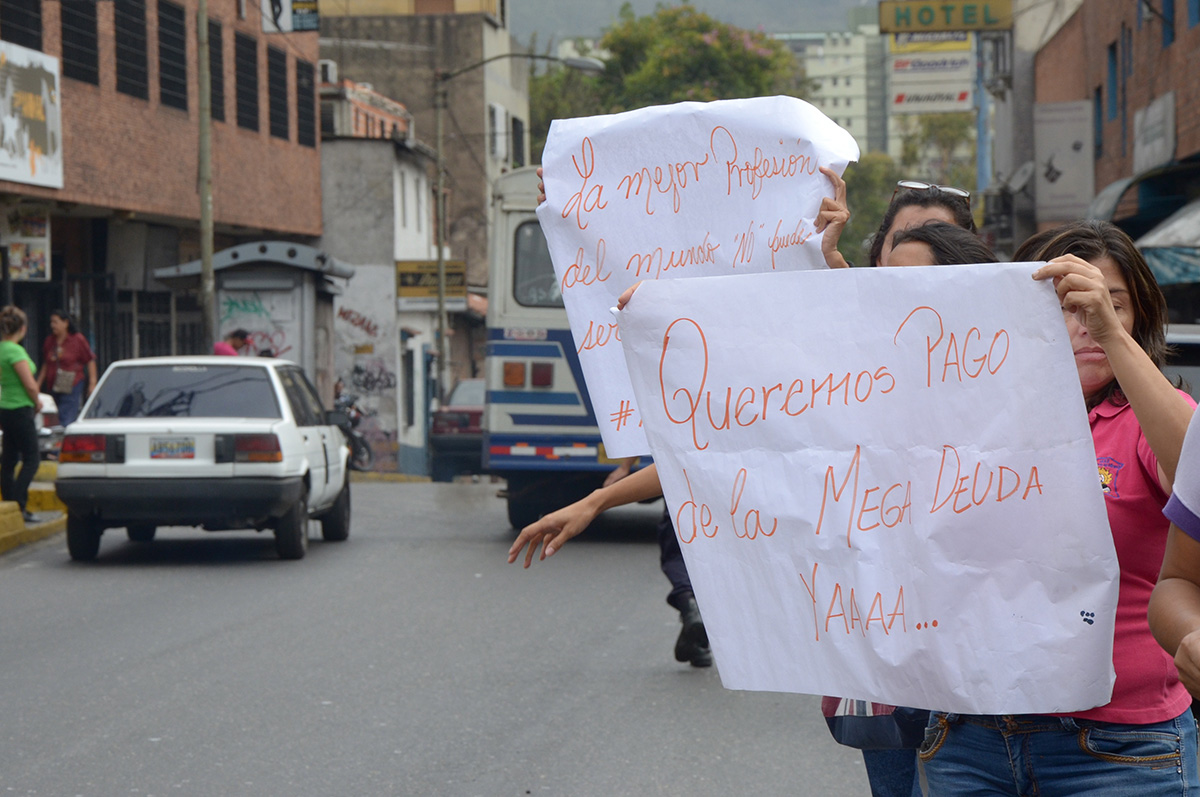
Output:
[{"xmin": 538, "ymin": 97, "xmax": 858, "ymax": 457}]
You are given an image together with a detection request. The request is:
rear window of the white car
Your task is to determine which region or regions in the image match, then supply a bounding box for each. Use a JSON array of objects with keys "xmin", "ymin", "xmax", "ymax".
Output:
[{"xmin": 86, "ymin": 364, "xmax": 281, "ymax": 418}]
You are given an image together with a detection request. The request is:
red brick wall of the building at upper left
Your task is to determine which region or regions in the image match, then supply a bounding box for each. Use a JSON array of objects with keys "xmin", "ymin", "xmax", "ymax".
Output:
[{"xmin": 0, "ymin": 0, "xmax": 322, "ymax": 235}]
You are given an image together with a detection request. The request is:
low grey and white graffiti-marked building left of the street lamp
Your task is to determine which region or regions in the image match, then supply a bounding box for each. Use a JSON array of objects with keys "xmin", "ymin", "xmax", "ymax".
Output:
[{"xmin": 320, "ymin": 78, "xmax": 446, "ymax": 475}]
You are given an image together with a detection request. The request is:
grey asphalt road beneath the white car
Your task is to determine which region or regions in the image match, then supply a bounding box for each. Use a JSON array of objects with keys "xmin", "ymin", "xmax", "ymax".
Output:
[{"xmin": 0, "ymin": 484, "xmax": 869, "ymax": 797}]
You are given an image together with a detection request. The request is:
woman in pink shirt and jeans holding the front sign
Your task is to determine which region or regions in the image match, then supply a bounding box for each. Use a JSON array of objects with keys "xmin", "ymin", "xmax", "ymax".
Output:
[{"xmin": 919, "ymin": 221, "xmax": 1200, "ymax": 796}]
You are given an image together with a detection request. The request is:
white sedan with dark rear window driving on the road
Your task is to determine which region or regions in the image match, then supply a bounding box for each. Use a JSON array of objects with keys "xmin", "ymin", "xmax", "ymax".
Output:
[{"xmin": 54, "ymin": 356, "xmax": 350, "ymax": 561}]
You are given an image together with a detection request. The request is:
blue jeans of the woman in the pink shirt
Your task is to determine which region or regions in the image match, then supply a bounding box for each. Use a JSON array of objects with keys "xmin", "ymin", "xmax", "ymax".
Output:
[{"xmin": 918, "ymin": 709, "xmax": 1200, "ymax": 797}]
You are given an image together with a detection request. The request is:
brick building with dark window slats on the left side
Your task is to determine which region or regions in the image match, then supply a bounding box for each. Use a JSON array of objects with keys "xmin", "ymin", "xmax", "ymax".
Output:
[{"xmin": 0, "ymin": 0, "xmax": 322, "ymax": 365}]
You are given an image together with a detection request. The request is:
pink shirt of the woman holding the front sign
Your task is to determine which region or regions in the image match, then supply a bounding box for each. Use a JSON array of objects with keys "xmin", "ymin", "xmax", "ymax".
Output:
[{"xmin": 1069, "ymin": 390, "xmax": 1195, "ymax": 725}]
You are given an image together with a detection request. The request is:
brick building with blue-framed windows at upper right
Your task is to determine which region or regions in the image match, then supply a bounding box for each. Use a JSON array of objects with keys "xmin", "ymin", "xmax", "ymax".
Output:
[{"xmin": 1034, "ymin": 0, "xmax": 1200, "ymax": 322}]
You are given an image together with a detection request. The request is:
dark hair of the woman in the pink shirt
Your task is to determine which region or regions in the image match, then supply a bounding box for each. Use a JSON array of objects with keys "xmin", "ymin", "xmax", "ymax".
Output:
[{"xmin": 1014, "ymin": 220, "xmax": 1170, "ymax": 401}]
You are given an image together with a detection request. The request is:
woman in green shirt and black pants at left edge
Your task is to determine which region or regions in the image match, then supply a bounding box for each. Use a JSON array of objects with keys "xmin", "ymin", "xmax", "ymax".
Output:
[{"xmin": 0, "ymin": 305, "xmax": 42, "ymax": 522}]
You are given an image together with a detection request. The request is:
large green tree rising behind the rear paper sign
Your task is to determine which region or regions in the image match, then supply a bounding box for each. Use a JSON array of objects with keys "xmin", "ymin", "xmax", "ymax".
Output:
[{"xmin": 529, "ymin": 2, "xmax": 806, "ymax": 162}]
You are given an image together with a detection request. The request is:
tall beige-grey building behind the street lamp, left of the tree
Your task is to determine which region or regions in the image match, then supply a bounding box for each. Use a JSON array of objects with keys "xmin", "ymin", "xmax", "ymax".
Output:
[{"xmin": 320, "ymin": 0, "xmax": 529, "ymax": 392}]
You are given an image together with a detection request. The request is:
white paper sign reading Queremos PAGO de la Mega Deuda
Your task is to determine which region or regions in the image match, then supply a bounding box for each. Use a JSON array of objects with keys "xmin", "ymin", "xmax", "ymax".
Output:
[{"xmin": 620, "ymin": 263, "xmax": 1118, "ymax": 714}]
